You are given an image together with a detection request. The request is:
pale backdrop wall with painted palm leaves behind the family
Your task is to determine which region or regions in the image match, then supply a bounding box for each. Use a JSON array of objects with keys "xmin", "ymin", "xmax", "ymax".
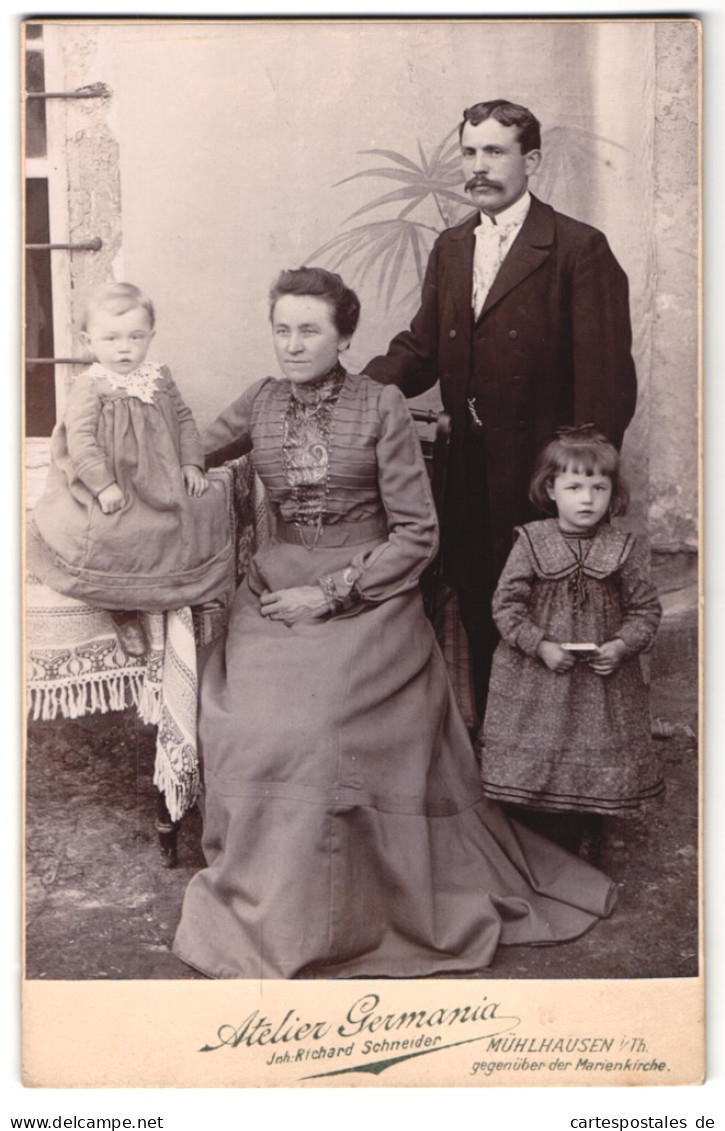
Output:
[{"xmin": 32, "ymin": 20, "xmax": 698, "ymax": 546}]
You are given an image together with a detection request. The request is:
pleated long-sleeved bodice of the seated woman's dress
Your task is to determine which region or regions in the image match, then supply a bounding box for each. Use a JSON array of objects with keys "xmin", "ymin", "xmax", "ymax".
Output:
[{"xmin": 202, "ymin": 371, "xmax": 438, "ymax": 602}]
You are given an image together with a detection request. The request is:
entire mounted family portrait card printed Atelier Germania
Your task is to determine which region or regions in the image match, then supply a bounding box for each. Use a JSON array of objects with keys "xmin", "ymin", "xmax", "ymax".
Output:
[{"xmin": 20, "ymin": 17, "xmax": 705, "ymax": 1087}]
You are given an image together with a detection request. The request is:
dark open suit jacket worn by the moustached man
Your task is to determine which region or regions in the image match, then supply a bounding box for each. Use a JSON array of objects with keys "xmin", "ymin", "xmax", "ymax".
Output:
[{"xmin": 365, "ymin": 196, "xmax": 637, "ymax": 585}]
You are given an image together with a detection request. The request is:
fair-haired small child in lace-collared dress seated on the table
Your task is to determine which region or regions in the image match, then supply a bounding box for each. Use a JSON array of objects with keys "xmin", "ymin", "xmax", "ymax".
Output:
[{"xmin": 28, "ymin": 283, "xmax": 232, "ymax": 656}]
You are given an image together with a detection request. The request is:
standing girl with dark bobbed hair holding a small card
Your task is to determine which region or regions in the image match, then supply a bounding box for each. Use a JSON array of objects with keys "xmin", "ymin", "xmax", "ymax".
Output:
[{"xmin": 478, "ymin": 425, "xmax": 663, "ymax": 861}]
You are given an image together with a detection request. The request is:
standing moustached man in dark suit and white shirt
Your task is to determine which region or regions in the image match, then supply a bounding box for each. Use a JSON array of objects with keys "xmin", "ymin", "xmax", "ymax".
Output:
[{"xmin": 365, "ymin": 98, "xmax": 637, "ymax": 714}]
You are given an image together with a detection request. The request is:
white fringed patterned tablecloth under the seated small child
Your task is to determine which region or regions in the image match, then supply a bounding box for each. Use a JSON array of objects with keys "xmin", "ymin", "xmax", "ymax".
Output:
[{"xmin": 25, "ymin": 456, "xmax": 269, "ymax": 820}]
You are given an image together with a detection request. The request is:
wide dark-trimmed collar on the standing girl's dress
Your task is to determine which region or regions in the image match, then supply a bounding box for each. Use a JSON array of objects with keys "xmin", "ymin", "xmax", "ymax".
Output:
[{"xmin": 516, "ymin": 518, "xmax": 635, "ymax": 578}]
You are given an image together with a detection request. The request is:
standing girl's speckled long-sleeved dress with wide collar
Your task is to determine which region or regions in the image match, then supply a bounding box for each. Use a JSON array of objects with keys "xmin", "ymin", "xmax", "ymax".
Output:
[{"xmin": 478, "ymin": 519, "xmax": 663, "ymax": 817}]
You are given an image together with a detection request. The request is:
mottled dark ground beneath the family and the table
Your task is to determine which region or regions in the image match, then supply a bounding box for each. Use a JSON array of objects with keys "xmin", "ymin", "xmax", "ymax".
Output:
[{"xmin": 25, "ymin": 556, "xmax": 698, "ymax": 979}]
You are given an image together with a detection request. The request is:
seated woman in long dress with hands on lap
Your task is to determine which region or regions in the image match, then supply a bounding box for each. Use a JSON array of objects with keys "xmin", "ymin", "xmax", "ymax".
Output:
[{"xmin": 174, "ymin": 267, "xmax": 614, "ymax": 978}]
